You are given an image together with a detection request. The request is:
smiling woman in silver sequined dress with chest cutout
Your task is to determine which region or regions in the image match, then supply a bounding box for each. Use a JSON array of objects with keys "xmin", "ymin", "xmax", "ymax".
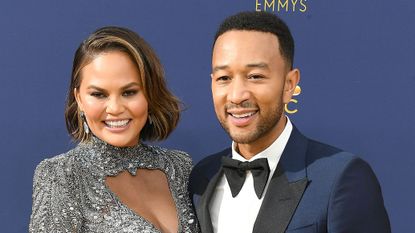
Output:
[{"xmin": 29, "ymin": 27, "xmax": 198, "ymax": 233}]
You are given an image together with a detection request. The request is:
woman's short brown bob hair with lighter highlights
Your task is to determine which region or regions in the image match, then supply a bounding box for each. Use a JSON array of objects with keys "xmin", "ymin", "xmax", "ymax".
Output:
[{"xmin": 65, "ymin": 27, "xmax": 181, "ymax": 142}]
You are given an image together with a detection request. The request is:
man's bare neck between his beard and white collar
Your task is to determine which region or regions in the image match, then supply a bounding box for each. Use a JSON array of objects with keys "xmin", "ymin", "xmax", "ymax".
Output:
[{"xmin": 235, "ymin": 115, "xmax": 287, "ymax": 160}]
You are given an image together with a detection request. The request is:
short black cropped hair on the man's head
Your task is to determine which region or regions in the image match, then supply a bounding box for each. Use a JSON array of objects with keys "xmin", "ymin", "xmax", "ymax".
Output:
[{"xmin": 214, "ymin": 11, "xmax": 294, "ymax": 67}]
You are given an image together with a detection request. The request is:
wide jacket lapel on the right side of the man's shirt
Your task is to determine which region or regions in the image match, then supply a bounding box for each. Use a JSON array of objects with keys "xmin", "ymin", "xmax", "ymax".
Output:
[{"xmin": 253, "ymin": 127, "xmax": 308, "ymax": 233}]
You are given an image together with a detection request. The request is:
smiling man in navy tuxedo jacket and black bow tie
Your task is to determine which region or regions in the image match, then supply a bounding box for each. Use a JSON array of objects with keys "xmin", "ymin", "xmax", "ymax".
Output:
[{"xmin": 190, "ymin": 12, "xmax": 390, "ymax": 233}]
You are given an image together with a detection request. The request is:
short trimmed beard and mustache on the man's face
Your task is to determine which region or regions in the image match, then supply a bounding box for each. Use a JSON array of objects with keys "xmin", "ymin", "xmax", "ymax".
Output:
[{"xmin": 219, "ymin": 101, "xmax": 284, "ymax": 144}]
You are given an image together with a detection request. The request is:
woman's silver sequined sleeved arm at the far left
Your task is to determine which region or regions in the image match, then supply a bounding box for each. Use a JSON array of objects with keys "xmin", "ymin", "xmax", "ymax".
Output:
[{"xmin": 29, "ymin": 156, "xmax": 82, "ymax": 233}]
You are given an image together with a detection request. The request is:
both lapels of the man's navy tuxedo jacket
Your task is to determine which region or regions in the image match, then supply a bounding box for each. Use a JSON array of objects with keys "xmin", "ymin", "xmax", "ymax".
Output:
[{"xmin": 196, "ymin": 125, "xmax": 308, "ymax": 233}]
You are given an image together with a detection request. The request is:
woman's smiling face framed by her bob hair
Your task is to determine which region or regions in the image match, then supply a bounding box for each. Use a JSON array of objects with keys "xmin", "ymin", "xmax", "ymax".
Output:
[{"xmin": 74, "ymin": 51, "xmax": 148, "ymax": 147}]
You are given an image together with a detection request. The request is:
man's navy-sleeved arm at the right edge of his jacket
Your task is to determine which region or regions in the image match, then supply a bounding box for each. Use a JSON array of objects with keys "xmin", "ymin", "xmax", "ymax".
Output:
[{"xmin": 327, "ymin": 158, "xmax": 391, "ymax": 233}]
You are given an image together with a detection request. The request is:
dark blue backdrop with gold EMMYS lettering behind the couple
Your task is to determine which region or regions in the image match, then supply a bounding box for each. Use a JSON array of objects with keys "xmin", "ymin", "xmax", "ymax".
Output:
[{"xmin": 0, "ymin": 0, "xmax": 415, "ymax": 233}]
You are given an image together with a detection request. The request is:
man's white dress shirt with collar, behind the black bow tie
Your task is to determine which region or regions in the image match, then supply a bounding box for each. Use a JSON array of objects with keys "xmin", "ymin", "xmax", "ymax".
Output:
[{"xmin": 209, "ymin": 117, "xmax": 292, "ymax": 233}]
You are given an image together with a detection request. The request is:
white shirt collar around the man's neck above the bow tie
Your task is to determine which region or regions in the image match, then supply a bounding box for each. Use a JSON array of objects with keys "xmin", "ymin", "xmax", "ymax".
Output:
[{"xmin": 232, "ymin": 116, "xmax": 293, "ymax": 170}]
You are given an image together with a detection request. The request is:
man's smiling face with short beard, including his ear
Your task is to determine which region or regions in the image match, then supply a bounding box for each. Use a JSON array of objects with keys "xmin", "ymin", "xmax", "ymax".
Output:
[{"xmin": 211, "ymin": 30, "xmax": 299, "ymax": 149}]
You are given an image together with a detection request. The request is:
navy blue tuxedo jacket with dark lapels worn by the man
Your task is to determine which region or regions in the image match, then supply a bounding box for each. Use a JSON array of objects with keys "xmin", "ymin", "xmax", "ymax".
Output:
[{"xmin": 189, "ymin": 127, "xmax": 390, "ymax": 233}]
